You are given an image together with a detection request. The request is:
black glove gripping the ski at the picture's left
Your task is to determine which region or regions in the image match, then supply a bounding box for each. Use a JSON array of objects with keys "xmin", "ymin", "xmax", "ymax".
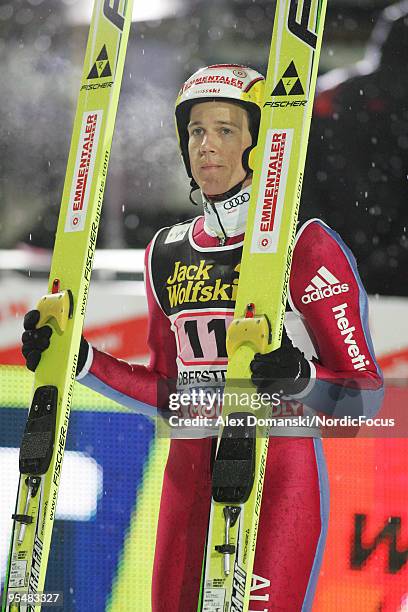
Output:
[{"xmin": 21, "ymin": 310, "xmax": 89, "ymax": 376}]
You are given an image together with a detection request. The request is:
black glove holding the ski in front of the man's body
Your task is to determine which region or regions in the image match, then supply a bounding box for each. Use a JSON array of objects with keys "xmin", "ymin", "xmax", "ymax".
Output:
[{"xmin": 250, "ymin": 328, "xmax": 310, "ymax": 395}]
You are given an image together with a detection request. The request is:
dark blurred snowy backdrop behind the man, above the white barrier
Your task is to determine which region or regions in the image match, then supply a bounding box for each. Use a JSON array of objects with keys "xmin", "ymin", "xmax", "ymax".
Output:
[{"xmin": 0, "ymin": 0, "xmax": 408, "ymax": 295}]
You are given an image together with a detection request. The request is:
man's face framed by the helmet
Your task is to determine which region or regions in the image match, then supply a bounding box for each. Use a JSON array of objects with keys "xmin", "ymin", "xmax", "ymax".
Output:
[{"xmin": 187, "ymin": 101, "xmax": 252, "ymax": 196}]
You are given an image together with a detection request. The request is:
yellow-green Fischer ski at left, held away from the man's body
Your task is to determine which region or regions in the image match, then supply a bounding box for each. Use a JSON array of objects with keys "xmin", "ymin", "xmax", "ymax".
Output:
[{"xmin": 2, "ymin": 0, "xmax": 133, "ymax": 612}]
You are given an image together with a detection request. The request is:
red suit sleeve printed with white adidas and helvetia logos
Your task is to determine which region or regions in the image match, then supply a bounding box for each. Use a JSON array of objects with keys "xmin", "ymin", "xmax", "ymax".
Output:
[{"xmin": 289, "ymin": 219, "xmax": 383, "ymax": 416}]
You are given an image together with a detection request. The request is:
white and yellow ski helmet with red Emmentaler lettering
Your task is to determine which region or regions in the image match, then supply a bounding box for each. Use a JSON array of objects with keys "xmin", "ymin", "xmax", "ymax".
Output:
[{"xmin": 176, "ymin": 64, "xmax": 265, "ymax": 178}]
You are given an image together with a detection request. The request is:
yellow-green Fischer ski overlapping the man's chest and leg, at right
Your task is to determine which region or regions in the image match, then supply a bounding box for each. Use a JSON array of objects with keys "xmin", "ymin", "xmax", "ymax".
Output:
[{"xmin": 198, "ymin": 0, "xmax": 327, "ymax": 612}]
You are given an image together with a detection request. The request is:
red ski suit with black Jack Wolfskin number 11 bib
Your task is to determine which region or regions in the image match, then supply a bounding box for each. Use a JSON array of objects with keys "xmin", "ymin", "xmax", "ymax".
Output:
[{"xmin": 79, "ymin": 217, "xmax": 383, "ymax": 612}]
